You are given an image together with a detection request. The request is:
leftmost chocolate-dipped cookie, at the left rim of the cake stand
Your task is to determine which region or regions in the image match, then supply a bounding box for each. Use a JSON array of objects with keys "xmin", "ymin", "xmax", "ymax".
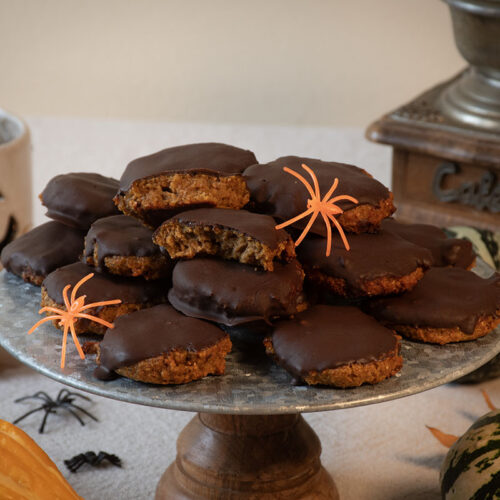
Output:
[{"xmin": 0, "ymin": 221, "xmax": 85, "ymax": 286}]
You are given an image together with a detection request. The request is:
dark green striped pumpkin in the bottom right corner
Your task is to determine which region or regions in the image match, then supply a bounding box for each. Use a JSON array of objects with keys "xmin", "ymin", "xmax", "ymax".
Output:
[{"xmin": 440, "ymin": 410, "xmax": 500, "ymax": 500}]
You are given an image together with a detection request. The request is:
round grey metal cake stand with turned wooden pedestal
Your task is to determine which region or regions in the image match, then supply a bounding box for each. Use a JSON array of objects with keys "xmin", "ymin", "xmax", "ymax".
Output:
[{"xmin": 0, "ymin": 262, "xmax": 500, "ymax": 500}]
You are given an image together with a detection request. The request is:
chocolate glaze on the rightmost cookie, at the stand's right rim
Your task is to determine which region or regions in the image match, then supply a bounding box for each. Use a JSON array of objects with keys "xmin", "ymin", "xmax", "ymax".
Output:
[{"xmin": 366, "ymin": 267, "xmax": 500, "ymax": 334}]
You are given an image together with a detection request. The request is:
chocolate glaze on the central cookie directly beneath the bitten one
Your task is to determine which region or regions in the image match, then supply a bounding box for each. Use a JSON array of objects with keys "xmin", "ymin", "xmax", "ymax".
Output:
[{"xmin": 168, "ymin": 258, "xmax": 304, "ymax": 326}]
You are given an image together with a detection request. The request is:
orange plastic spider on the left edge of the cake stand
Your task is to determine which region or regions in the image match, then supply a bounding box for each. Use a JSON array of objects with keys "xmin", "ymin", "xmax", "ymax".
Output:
[{"xmin": 28, "ymin": 273, "xmax": 121, "ymax": 368}]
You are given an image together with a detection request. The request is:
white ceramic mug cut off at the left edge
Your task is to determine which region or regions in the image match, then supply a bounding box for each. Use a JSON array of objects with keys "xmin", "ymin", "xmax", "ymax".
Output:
[{"xmin": 0, "ymin": 109, "xmax": 32, "ymax": 250}]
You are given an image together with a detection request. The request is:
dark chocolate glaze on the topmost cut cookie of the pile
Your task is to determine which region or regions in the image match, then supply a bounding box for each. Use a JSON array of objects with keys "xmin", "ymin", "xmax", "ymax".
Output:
[{"xmin": 120, "ymin": 142, "xmax": 257, "ymax": 193}]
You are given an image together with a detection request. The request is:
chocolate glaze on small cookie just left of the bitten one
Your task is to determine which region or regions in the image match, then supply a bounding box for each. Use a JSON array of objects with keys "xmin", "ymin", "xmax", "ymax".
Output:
[{"xmin": 84, "ymin": 215, "xmax": 168, "ymax": 271}]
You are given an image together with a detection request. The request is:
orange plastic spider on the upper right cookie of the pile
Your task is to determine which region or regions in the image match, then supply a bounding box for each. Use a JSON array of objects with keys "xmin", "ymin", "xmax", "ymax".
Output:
[{"xmin": 276, "ymin": 163, "xmax": 359, "ymax": 257}]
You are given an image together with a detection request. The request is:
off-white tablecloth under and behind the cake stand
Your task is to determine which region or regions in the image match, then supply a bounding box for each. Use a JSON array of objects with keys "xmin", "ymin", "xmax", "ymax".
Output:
[{"xmin": 0, "ymin": 118, "xmax": 500, "ymax": 500}]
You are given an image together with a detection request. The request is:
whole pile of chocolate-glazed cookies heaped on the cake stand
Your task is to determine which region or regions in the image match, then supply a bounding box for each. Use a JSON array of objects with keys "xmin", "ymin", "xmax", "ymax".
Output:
[{"xmin": 2, "ymin": 143, "xmax": 500, "ymax": 387}]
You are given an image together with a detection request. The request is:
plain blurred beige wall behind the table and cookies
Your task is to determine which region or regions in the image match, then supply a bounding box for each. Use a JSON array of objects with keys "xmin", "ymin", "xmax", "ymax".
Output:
[{"xmin": 0, "ymin": 0, "xmax": 465, "ymax": 126}]
